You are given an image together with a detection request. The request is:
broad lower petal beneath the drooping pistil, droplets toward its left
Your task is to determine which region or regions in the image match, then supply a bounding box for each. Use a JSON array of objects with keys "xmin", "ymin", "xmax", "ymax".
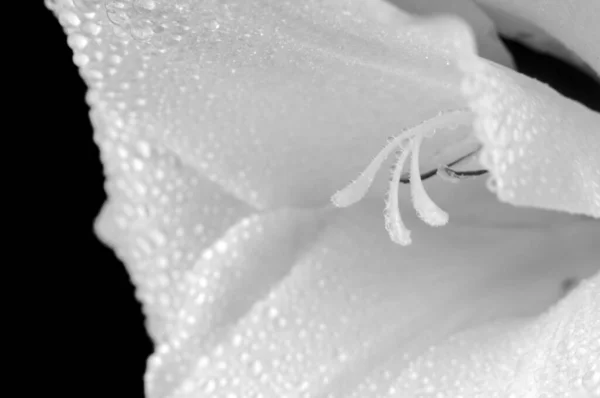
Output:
[{"xmin": 149, "ymin": 199, "xmax": 599, "ymax": 397}]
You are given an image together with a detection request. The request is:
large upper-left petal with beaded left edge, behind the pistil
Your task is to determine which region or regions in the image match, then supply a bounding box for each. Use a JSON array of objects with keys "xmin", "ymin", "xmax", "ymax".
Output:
[{"xmin": 48, "ymin": 0, "xmax": 506, "ymax": 341}]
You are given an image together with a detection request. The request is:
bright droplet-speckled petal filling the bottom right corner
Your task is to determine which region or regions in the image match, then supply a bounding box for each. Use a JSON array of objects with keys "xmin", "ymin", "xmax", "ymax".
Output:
[{"xmin": 378, "ymin": 274, "xmax": 600, "ymax": 398}]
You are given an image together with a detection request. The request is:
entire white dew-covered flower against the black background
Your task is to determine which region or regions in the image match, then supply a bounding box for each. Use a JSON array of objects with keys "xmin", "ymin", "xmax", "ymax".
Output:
[{"xmin": 46, "ymin": 0, "xmax": 600, "ymax": 398}]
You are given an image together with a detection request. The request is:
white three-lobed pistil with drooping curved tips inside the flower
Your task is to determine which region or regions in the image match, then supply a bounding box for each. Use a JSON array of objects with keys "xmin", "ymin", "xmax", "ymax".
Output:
[{"xmin": 331, "ymin": 109, "xmax": 474, "ymax": 246}]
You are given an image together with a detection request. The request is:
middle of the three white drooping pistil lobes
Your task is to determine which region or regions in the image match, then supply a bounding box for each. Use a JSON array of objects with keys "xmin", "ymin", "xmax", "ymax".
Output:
[{"xmin": 383, "ymin": 143, "xmax": 412, "ymax": 246}]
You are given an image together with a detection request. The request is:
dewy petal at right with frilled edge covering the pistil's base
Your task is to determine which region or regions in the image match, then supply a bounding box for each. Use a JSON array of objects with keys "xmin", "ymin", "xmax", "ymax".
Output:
[{"xmin": 454, "ymin": 57, "xmax": 600, "ymax": 218}]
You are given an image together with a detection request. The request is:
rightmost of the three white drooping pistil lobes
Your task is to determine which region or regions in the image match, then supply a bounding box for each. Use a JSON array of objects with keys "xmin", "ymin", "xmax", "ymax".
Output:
[{"xmin": 410, "ymin": 135, "xmax": 448, "ymax": 227}]
